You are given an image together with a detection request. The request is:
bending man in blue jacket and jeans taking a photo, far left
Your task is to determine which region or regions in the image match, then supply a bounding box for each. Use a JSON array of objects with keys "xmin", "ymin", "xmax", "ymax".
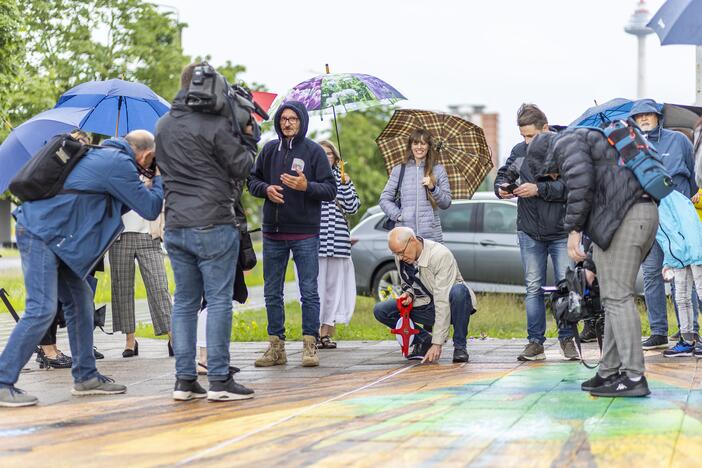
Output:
[{"xmin": 0, "ymin": 130, "xmax": 163, "ymax": 407}]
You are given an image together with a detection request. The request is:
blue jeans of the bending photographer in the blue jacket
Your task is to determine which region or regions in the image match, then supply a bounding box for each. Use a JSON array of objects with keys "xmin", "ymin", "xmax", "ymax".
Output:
[{"xmin": 0, "ymin": 224, "xmax": 98, "ymax": 386}]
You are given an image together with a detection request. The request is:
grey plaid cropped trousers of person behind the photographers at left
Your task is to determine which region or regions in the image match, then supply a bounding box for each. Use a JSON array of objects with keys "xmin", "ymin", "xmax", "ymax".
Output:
[{"xmin": 109, "ymin": 232, "xmax": 173, "ymax": 335}]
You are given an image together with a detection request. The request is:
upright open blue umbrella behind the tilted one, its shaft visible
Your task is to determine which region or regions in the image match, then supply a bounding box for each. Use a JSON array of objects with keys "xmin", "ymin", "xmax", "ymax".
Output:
[{"xmin": 55, "ymin": 79, "xmax": 170, "ymax": 136}]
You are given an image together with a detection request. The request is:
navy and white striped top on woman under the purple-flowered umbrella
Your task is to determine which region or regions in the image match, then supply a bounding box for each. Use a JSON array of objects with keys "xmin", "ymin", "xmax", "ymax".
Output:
[{"xmin": 319, "ymin": 166, "xmax": 361, "ymax": 257}]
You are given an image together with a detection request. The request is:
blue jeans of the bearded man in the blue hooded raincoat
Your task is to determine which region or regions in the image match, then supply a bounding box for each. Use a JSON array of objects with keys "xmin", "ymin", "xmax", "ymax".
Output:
[{"xmin": 641, "ymin": 242, "xmax": 674, "ymax": 336}]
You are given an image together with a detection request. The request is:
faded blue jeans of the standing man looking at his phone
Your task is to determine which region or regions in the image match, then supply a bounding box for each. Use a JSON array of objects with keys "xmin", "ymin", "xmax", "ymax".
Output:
[{"xmin": 517, "ymin": 231, "xmax": 573, "ymax": 344}]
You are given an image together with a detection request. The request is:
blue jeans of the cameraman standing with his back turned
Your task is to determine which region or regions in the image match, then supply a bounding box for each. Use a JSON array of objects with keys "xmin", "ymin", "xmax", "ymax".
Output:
[{"xmin": 164, "ymin": 224, "xmax": 240, "ymax": 381}]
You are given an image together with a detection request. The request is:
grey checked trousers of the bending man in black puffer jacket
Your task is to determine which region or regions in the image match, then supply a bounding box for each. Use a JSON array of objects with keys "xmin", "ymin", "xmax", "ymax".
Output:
[{"xmin": 592, "ymin": 202, "xmax": 658, "ymax": 377}]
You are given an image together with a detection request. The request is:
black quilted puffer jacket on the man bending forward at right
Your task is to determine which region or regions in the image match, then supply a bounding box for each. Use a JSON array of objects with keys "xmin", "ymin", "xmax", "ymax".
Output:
[{"xmin": 545, "ymin": 128, "xmax": 644, "ymax": 250}]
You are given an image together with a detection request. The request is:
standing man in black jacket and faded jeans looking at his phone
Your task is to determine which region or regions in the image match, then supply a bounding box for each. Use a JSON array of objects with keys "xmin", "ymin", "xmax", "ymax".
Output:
[{"xmin": 494, "ymin": 104, "xmax": 578, "ymax": 361}]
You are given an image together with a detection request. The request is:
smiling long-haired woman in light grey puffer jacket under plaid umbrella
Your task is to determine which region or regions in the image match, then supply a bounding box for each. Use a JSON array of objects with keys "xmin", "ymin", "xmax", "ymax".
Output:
[{"xmin": 380, "ymin": 129, "xmax": 451, "ymax": 242}]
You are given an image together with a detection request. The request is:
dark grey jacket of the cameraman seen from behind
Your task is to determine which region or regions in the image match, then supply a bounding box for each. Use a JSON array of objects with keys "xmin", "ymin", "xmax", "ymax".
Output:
[{"xmin": 156, "ymin": 91, "xmax": 256, "ymax": 229}]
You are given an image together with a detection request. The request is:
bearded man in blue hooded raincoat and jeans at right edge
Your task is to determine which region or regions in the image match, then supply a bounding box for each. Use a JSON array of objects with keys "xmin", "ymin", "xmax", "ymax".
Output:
[{"xmin": 629, "ymin": 99, "xmax": 698, "ymax": 350}]
